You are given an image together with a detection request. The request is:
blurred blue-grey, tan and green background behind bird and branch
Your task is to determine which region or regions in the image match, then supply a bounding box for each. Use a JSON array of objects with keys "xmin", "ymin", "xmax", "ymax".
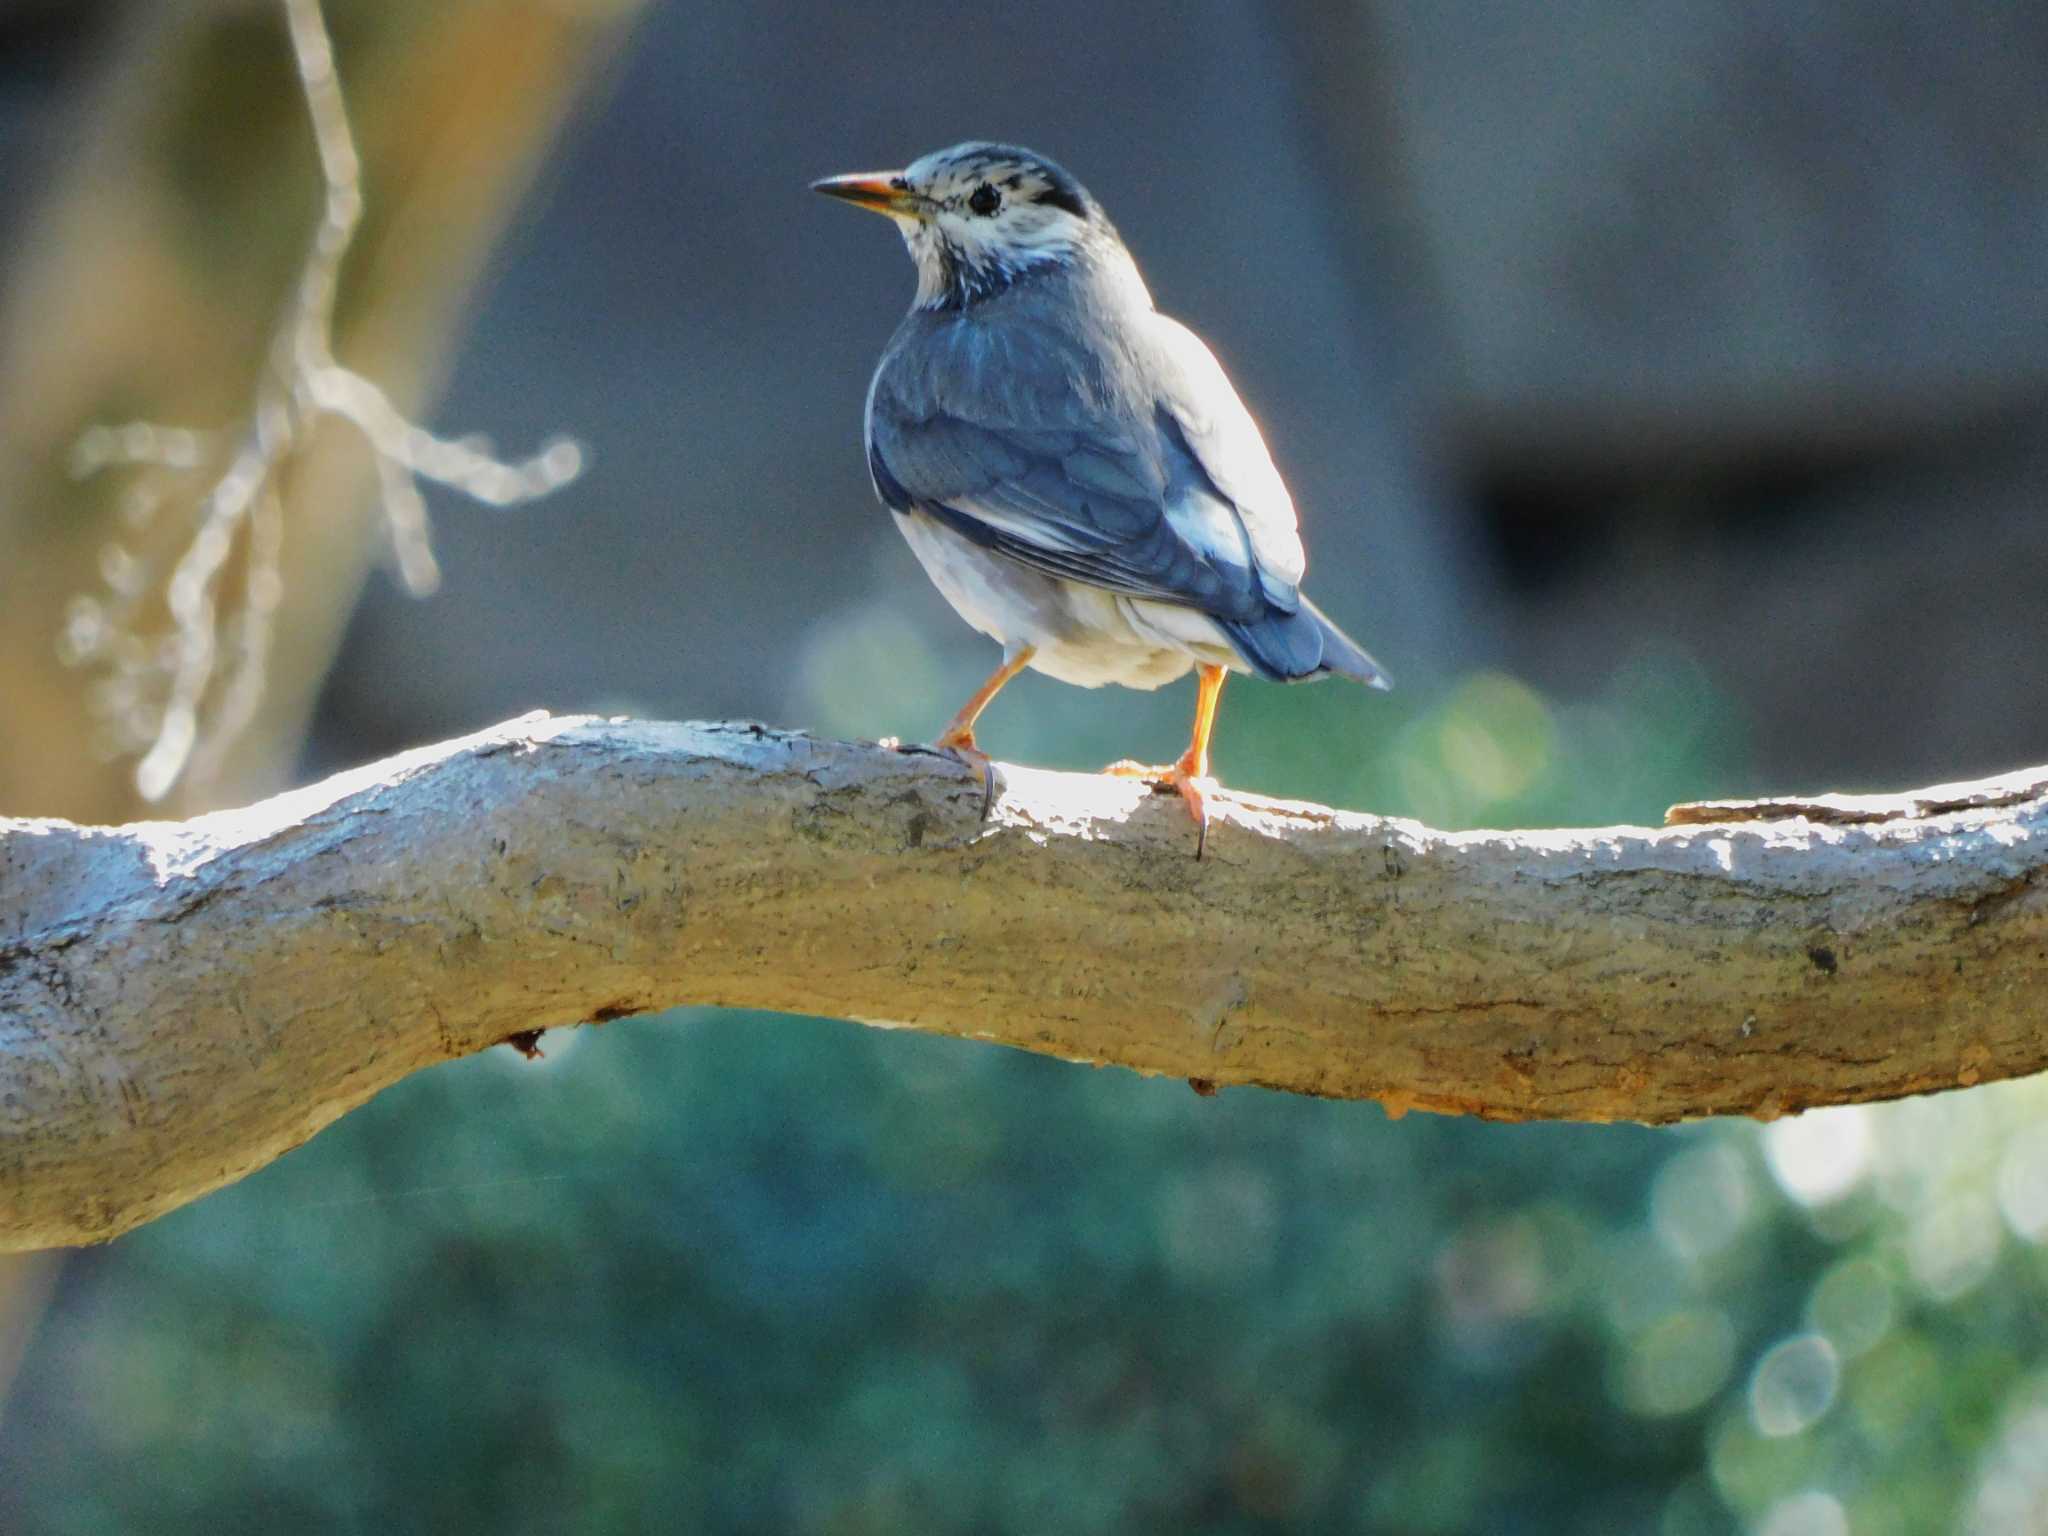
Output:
[{"xmin": 0, "ymin": 0, "xmax": 2048, "ymax": 1536}]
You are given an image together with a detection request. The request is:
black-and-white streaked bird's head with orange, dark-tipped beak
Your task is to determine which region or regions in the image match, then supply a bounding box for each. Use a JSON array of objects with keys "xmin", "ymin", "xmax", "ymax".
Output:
[{"xmin": 813, "ymin": 141, "xmax": 1135, "ymax": 309}]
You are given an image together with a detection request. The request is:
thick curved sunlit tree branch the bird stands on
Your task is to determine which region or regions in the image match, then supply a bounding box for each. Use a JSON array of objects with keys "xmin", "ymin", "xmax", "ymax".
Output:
[{"xmin": 0, "ymin": 717, "xmax": 2048, "ymax": 1247}]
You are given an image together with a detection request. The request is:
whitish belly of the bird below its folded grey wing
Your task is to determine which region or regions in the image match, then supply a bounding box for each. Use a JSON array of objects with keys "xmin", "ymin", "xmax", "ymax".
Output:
[{"xmin": 895, "ymin": 512, "xmax": 1247, "ymax": 688}]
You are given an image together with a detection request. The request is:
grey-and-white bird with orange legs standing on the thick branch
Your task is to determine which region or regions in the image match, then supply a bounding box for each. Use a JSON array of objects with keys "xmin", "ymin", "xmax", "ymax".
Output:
[{"xmin": 811, "ymin": 139, "xmax": 1391, "ymax": 858}]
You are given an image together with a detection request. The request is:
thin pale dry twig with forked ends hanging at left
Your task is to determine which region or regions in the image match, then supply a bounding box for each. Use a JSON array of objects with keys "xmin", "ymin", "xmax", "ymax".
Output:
[{"xmin": 61, "ymin": 0, "xmax": 582, "ymax": 801}]
